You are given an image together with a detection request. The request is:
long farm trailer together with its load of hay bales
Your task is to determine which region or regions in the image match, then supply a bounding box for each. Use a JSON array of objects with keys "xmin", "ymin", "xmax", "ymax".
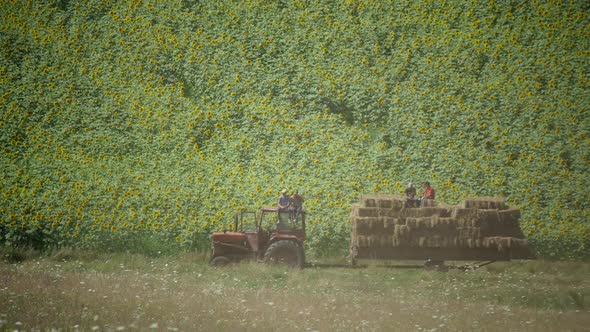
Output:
[{"xmin": 350, "ymin": 195, "xmax": 534, "ymax": 267}]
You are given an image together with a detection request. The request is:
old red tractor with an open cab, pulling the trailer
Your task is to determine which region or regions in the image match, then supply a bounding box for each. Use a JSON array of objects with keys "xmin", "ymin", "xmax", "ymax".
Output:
[{"xmin": 210, "ymin": 208, "xmax": 305, "ymax": 268}]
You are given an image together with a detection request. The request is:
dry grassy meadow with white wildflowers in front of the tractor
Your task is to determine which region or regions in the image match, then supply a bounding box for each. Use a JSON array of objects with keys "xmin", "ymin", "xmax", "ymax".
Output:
[{"xmin": 0, "ymin": 251, "xmax": 590, "ymax": 331}]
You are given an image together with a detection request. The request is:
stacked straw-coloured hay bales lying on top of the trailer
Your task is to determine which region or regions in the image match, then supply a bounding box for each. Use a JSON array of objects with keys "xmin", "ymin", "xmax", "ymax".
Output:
[{"xmin": 351, "ymin": 195, "xmax": 527, "ymax": 255}]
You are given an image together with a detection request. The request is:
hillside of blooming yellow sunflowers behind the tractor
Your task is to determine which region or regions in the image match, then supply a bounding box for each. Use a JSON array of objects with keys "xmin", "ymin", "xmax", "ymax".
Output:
[{"xmin": 0, "ymin": 0, "xmax": 590, "ymax": 258}]
